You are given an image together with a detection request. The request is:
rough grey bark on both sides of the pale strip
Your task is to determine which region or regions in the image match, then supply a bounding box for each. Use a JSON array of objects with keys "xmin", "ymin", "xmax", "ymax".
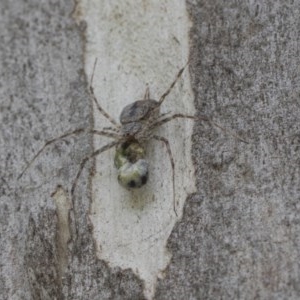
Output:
[{"xmin": 0, "ymin": 0, "xmax": 300, "ymax": 299}]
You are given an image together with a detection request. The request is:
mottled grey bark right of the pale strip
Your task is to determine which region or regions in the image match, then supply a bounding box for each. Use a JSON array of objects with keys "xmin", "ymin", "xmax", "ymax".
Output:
[{"xmin": 157, "ymin": 1, "xmax": 300, "ymax": 299}]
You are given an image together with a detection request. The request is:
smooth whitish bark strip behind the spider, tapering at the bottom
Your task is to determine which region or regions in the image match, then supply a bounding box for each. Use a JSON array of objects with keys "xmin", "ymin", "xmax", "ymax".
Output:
[{"xmin": 74, "ymin": 0, "xmax": 195, "ymax": 299}]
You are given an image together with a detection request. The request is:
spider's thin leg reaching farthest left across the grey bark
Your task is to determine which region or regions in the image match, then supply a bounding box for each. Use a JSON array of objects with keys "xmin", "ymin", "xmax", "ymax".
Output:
[{"xmin": 17, "ymin": 128, "xmax": 119, "ymax": 180}]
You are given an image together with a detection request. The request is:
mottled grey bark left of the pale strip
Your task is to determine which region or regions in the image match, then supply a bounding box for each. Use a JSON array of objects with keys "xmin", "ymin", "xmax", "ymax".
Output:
[{"xmin": 0, "ymin": 0, "xmax": 143, "ymax": 300}]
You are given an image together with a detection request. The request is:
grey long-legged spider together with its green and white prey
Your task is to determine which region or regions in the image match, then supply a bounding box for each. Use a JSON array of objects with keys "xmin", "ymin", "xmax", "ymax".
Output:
[{"xmin": 18, "ymin": 59, "xmax": 244, "ymax": 216}]
